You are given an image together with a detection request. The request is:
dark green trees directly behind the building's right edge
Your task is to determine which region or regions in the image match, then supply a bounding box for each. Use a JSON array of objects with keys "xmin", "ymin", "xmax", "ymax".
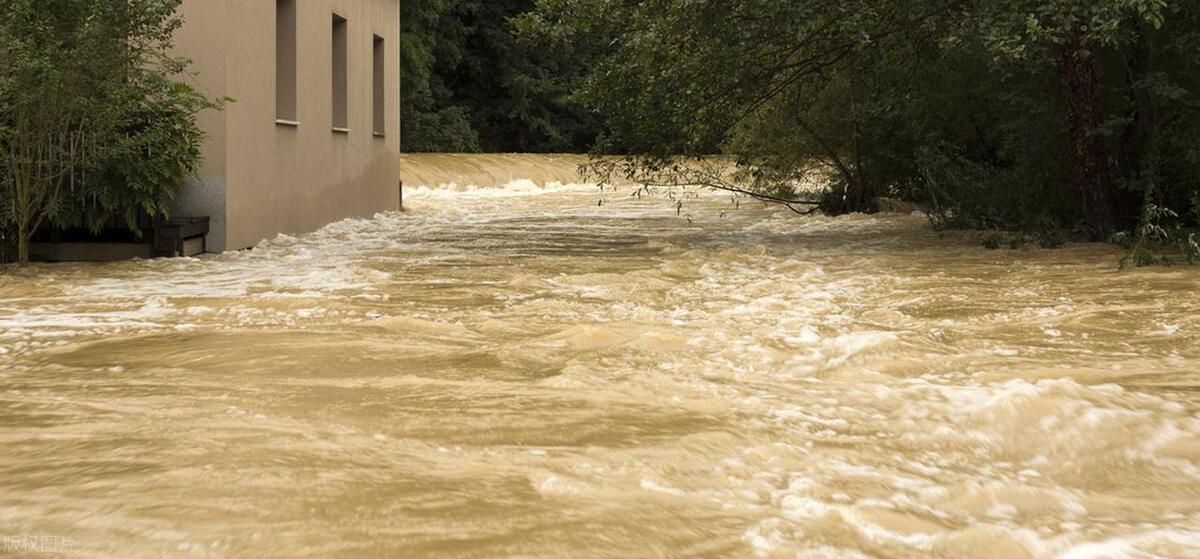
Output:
[{"xmin": 401, "ymin": 0, "xmax": 599, "ymax": 152}]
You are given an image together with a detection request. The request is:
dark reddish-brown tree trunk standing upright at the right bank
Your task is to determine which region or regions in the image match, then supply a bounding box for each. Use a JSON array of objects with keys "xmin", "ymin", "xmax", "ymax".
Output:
[{"xmin": 1062, "ymin": 28, "xmax": 1116, "ymax": 240}]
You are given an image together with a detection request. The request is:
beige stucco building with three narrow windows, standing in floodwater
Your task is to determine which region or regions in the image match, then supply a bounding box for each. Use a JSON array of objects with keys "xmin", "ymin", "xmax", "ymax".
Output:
[{"xmin": 175, "ymin": 0, "xmax": 400, "ymax": 252}]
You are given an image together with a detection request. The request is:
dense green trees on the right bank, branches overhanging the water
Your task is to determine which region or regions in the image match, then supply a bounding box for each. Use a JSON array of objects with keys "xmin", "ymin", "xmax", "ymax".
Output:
[{"xmin": 521, "ymin": 0, "xmax": 1200, "ymax": 260}]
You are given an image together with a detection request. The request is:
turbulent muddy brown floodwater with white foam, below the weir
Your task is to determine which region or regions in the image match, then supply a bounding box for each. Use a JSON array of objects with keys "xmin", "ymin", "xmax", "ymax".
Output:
[{"xmin": 0, "ymin": 153, "xmax": 1200, "ymax": 558}]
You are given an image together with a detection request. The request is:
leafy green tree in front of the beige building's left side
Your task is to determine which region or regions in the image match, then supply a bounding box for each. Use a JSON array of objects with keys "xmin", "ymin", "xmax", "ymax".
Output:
[{"xmin": 0, "ymin": 0, "xmax": 214, "ymax": 262}]
